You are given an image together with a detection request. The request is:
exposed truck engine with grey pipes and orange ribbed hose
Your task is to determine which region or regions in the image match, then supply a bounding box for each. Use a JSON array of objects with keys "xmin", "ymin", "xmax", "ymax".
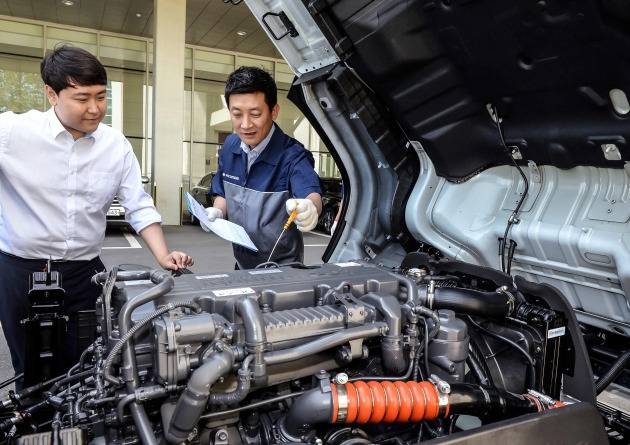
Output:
[{"xmin": 0, "ymin": 253, "xmax": 607, "ymax": 445}]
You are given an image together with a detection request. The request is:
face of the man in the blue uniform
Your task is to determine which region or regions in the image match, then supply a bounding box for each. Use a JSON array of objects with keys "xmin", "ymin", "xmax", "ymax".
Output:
[{"xmin": 230, "ymin": 92, "xmax": 280, "ymax": 148}]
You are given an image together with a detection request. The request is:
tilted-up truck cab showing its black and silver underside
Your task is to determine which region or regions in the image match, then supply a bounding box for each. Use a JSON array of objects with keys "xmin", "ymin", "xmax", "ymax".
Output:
[{"xmin": 246, "ymin": 0, "xmax": 630, "ymax": 335}]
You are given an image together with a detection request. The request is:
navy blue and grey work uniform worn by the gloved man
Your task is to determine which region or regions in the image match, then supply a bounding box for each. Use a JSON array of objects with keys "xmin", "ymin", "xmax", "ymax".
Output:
[{"xmin": 210, "ymin": 123, "xmax": 322, "ymax": 269}]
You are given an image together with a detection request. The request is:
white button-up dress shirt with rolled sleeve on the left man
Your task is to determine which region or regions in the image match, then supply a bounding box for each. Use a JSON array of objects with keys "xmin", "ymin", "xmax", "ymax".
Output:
[{"xmin": 0, "ymin": 108, "xmax": 162, "ymax": 260}]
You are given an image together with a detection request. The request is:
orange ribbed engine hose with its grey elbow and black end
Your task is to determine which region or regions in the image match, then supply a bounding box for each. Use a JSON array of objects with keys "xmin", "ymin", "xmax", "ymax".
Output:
[{"xmin": 278, "ymin": 381, "xmax": 563, "ymax": 441}]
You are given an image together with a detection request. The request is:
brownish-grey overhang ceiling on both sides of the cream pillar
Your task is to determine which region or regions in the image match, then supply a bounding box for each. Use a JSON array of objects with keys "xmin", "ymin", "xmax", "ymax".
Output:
[{"xmin": 0, "ymin": 0, "xmax": 281, "ymax": 58}]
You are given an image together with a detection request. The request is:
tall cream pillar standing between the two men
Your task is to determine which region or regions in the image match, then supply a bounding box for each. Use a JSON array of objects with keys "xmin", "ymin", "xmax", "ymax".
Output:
[{"xmin": 152, "ymin": 0, "xmax": 186, "ymax": 225}]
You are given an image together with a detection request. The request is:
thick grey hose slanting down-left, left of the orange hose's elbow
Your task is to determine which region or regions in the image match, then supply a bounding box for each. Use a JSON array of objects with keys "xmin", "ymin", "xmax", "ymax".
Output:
[{"xmin": 165, "ymin": 348, "xmax": 234, "ymax": 444}]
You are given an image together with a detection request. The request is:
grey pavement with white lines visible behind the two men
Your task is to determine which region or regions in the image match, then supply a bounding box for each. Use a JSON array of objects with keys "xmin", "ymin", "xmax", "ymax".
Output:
[{"xmin": 0, "ymin": 225, "xmax": 330, "ymax": 392}]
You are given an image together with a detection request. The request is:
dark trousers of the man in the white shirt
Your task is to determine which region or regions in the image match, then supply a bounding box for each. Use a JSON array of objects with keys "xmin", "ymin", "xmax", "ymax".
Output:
[{"xmin": 0, "ymin": 253, "xmax": 105, "ymax": 386}]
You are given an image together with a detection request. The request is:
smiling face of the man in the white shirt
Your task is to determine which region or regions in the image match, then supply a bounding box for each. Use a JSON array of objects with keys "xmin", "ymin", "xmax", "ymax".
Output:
[{"xmin": 46, "ymin": 85, "xmax": 107, "ymax": 140}]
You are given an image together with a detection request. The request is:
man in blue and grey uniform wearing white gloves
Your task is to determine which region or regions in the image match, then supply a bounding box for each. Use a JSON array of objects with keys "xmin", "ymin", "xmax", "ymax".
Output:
[{"xmin": 202, "ymin": 67, "xmax": 322, "ymax": 269}]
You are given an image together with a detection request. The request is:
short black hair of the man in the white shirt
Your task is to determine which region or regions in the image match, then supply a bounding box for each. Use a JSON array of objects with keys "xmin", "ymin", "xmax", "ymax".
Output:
[{"xmin": 40, "ymin": 45, "xmax": 107, "ymax": 94}]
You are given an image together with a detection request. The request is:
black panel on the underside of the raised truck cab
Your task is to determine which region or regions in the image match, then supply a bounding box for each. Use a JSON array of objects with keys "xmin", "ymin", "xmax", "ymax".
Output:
[{"xmin": 266, "ymin": 0, "xmax": 630, "ymax": 180}]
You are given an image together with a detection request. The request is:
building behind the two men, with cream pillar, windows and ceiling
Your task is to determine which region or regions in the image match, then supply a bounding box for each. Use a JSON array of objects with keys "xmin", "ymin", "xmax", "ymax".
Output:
[{"xmin": 0, "ymin": 0, "xmax": 339, "ymax": 225}]
